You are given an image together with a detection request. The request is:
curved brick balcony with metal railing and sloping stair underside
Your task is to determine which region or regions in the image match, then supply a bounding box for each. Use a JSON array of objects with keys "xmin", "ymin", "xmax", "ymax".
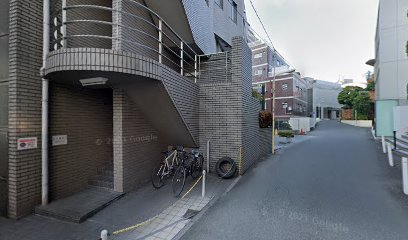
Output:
[{"xmin": 45, "ymin": 0, "xmax": 199, "ymax": 146}]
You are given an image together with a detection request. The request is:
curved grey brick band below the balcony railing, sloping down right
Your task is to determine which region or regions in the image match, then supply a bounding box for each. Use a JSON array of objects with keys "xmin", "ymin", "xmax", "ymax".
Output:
[{"xmin": 45, "ymin": 48, "xmax": 199, "ymax": 143}]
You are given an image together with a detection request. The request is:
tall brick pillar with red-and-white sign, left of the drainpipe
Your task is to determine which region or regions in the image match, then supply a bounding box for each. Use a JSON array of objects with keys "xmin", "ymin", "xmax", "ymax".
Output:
[{"xmin": 8, "ymin": 0, "xmax": 42, "ymax": 218}]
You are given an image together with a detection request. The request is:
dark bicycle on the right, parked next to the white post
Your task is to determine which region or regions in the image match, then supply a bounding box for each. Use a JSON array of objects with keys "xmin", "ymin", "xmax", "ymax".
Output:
[{"xmin": 172, "ymin": 149, "xmax": 204, "ymax": 197}]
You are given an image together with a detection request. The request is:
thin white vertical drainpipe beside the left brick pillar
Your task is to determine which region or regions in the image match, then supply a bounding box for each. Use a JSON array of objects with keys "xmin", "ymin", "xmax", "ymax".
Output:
[{"xmin": 41, "ymin": 0, "xmax": 50, "ymax": 205}]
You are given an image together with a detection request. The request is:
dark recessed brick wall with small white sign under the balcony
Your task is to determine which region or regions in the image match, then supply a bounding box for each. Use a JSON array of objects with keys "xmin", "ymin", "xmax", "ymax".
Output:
[{"xmin": 49, "ymin": 82, "xmax": 113, "ymax": 200}]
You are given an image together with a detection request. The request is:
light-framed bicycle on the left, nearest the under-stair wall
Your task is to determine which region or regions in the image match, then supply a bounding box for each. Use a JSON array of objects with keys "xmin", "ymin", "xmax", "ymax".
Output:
[{"xmin": 152, "ymin": 146, "xmax": 184, "ymax": 189}]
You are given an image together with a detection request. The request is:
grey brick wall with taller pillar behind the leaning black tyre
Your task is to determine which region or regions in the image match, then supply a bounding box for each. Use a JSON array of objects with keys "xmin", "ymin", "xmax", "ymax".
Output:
[{"xmin": 199, "ymin": 37, "xmax": 265, "ymax": 173}]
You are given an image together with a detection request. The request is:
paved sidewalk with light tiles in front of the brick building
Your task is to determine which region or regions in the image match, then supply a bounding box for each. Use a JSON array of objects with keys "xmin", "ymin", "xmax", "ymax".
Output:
[{"xmin": 0, "ymin": 175, "xmax": 234, "ymax": 240}]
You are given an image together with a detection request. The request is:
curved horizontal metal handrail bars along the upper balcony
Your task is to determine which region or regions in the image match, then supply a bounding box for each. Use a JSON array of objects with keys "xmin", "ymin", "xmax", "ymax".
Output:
[{"xmin": 53, "ymin": 0, "xmax": 197, "ymax": 81}]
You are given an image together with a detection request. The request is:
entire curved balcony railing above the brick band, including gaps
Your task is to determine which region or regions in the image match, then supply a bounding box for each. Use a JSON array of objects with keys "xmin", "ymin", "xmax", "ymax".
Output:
[{"xmin": 52, "ymin": 0, "xmax": 198, "ymax": 81}]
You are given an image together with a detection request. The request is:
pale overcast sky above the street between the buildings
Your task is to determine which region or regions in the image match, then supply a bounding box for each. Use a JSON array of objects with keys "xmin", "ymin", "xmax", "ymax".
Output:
[{"xmin": 245, "ymin": 0, "xmax": 378, "ymax": 82}]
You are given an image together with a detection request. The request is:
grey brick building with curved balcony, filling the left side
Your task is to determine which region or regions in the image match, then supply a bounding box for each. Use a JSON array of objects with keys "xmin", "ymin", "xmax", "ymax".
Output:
[{"xmin": 0, "ymin": 0, "xmax": 270, "ymax": 218}]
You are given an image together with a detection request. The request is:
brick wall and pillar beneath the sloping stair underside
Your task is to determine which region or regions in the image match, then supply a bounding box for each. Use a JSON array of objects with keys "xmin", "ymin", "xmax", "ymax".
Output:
[{"xmin": 113, "ymin": 89, "xmax": 167, "ymax": 192}]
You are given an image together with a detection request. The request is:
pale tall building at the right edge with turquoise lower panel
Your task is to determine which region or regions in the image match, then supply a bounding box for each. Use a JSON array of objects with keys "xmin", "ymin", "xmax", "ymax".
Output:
[{"xmin": 374, "ymin": 0, "xmax": 408, "ymax": 136}]
